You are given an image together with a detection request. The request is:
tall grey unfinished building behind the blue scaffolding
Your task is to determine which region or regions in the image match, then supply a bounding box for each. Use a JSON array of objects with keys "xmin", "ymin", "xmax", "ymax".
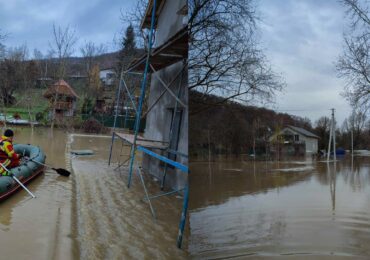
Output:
[{"xmin": 128, "ymin": 0, "xmax": 188, "ymax": 188}]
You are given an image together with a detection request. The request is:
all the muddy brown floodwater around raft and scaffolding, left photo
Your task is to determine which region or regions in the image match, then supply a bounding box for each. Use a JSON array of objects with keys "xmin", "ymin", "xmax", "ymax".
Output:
[{"xmin": 0, "ymin": 128, "xmax": 187, "ymax": 259}]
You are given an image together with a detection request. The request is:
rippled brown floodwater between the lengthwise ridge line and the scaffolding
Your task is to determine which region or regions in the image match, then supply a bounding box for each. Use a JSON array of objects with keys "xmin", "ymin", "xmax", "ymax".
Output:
[{"xmin": 71, "ymin": 135, "xmax": 186, "ymax": 259}]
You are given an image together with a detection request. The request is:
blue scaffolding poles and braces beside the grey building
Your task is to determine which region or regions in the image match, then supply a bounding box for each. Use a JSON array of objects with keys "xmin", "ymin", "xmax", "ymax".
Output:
[{"xmin": 109, "ymin": 0, "xmax": 189, "ymax": 248}]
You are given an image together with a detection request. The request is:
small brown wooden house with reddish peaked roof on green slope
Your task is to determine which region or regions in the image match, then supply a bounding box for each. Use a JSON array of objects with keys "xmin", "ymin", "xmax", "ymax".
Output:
[{"xmin": 44, "ymin": 79, "xmax": 78, "ymax": 118}]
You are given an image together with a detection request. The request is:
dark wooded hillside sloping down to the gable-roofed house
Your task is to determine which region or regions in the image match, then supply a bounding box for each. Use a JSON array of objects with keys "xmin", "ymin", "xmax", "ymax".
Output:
[{"xmin": 189, "ymin": 91, "xmax": 313, "ymax": 155}]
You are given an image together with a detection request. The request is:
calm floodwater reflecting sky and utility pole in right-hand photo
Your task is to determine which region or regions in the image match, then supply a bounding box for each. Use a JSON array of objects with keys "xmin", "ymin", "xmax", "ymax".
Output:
[{"xmin": 188, "ymin": 157, "xmax": 370, "ymax": 259}]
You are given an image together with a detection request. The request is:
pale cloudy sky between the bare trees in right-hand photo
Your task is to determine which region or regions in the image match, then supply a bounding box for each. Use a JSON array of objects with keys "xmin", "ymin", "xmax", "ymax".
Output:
[{"xmin": 258, "ymin": 0, "xmax": 351, "ymax": 126}]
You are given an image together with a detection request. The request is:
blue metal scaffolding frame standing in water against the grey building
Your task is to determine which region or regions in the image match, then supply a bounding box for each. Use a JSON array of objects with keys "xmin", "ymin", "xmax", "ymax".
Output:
[{"xmin": 108, "ymin": 0, "xmax": 189, "ymax": 248}]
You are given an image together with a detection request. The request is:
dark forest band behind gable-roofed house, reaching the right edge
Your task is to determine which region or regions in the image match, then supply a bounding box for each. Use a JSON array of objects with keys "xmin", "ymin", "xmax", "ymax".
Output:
[{"xmin": 189, "ymin": 91, "xmax": 370, "ymax": 158}]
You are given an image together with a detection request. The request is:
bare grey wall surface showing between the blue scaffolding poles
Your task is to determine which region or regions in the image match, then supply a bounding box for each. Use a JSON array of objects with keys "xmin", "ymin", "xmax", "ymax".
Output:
[{"xmin": 143, "ymin": 0, "xmax": 188, "ymax": 188}]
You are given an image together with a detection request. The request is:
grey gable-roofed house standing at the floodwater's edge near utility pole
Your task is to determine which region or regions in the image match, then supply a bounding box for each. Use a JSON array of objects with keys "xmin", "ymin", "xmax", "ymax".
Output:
[{"xmin": 269, "ymin": 126, "xmax": 319, "ymax": 155}]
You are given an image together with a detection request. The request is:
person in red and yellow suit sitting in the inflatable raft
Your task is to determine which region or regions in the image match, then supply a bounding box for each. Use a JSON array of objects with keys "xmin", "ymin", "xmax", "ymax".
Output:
[{"xmin": 0, "ymin": 129, "xmax": 21, "ymax": 176}]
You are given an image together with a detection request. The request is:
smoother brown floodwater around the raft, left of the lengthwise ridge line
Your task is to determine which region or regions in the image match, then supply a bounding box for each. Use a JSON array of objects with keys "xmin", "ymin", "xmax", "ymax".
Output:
[{"xmin": 0, "ymin": 128, "xmax": 78, "ymax": 259}]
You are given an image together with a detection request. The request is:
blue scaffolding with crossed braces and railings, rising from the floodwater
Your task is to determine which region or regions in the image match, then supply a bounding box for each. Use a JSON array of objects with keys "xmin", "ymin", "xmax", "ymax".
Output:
[{"xmin": 108, "ymin": 0, "xmax": 189, "ymax": 248}]
